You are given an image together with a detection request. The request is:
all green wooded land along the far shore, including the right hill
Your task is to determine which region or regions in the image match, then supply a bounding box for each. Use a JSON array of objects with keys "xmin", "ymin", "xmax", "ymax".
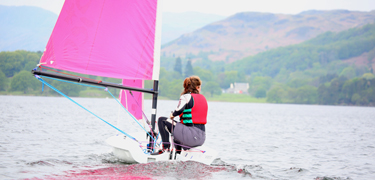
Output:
[{"xmin": 0, "ymin": 24, "xmax": 375, "ymax": 105}]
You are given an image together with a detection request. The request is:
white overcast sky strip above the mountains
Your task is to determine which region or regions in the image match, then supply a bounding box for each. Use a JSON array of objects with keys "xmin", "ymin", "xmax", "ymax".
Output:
[{"xmin": 0, "ymin": 0, "xmax": 375, "ymax": 16}]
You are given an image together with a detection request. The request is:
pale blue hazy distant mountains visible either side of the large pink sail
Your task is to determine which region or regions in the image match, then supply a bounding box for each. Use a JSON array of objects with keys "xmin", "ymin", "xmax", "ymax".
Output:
[{"xmin": 0, "ymin": 5, "xmax": 225, "ymax": 51}]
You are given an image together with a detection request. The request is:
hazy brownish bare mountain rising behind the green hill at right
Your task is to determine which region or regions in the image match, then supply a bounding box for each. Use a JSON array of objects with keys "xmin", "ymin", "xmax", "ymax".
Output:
[{"xmin": 162, "ymin": 10, "xmax": 375, "ymax": 62}]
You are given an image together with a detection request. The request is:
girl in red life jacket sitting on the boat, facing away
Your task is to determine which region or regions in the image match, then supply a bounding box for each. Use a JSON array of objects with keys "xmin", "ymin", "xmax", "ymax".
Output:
[{"xmin": 153, "ymin": 76, "xmax": 208, "ymax": 155}]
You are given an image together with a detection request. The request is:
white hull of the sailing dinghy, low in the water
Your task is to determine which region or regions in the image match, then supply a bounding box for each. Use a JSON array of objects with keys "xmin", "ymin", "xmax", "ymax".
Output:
[{"xmin": 106, "ymin": 132, "xmax": 217, "ymax": 165}]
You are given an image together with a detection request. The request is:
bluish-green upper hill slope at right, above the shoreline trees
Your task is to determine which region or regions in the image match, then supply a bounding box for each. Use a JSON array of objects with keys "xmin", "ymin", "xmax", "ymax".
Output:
[{"xmin": 226, "ymin": 24, "xmax": 375, "ymax": 78}]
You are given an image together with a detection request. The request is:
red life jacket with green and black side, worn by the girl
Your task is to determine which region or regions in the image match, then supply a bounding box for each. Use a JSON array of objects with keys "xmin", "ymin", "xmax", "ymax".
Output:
[{"xmin": 180, "ymin": 93, "xmax": 208, "ymax": 124}]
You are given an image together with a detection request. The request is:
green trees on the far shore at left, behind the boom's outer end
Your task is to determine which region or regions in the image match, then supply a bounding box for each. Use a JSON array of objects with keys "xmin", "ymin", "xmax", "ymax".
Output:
[{"xmin": 0, "ymin": 50, "xmax": 116, "ymax": 96}]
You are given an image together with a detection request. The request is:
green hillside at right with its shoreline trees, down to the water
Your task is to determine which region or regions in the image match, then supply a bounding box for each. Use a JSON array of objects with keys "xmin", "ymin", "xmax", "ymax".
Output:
[{"xmin": 224, "ymin": 24, "xmax": 375, "ymax": 106}]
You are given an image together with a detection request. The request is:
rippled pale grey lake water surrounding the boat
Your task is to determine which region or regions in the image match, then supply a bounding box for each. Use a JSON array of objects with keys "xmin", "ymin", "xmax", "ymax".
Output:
[{"xmin": 0, "ymin": 96, "xmax": 375, "ymax": 180}]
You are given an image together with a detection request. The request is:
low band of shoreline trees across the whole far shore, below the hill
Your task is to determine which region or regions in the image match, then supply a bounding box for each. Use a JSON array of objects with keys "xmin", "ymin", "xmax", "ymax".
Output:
[{"xmin": 0, "ymin": 51, "xmax": 375, "ymax": 106}]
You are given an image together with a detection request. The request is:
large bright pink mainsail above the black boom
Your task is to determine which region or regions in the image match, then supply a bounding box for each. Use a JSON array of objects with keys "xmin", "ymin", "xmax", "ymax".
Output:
[{"xmin": 40, "ymin": 0, "xmax": 161, "ymax": 80}]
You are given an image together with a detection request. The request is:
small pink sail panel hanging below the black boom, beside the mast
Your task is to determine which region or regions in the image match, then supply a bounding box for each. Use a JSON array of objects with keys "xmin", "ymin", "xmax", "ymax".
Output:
[{"xmin": 120, "ymin": 79, "xmax": 143, "ymax": 120}]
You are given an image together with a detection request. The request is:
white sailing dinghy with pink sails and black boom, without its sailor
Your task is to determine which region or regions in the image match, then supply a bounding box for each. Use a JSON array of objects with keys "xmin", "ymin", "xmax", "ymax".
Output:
[{"xmin": 32, "ymin": 0, "xmax": 217, "ymax": 164}]
